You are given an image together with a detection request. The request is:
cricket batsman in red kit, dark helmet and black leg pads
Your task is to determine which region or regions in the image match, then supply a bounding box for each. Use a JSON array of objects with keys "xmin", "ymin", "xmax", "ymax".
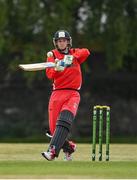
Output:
[{"xmin": 42, "ymin": 30, "xmax": 90, "ymax": 161}]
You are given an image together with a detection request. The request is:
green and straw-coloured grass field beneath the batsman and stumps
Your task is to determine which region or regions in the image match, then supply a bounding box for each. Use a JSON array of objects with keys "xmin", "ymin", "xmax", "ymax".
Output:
[{"xmin": 0, "ymin": 143, "xmax": 137, "ymax": 179}]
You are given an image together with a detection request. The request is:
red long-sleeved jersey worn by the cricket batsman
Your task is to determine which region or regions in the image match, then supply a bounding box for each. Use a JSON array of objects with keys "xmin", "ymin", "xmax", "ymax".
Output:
[{"xmin": 46, "ymin": 48, "xmax": 90, "ymax": 90}]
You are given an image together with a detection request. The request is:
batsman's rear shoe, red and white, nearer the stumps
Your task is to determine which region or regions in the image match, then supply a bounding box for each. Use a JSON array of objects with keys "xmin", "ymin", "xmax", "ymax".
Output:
[{"xmin": 64, "ymin": 141, "xmax": 77, "ymax": 161}]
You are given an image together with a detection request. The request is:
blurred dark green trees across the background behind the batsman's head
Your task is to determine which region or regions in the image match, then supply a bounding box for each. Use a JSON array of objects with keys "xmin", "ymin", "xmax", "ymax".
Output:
[{"xmin": 0, "ymin": 0, "xmax": 137, "ymax": 84}]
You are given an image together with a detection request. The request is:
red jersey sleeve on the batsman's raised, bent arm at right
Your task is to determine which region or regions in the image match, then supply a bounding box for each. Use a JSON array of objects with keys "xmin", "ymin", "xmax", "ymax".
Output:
[{"xmin": 73, "ymin": 48, "xmax": 90, "ymax": 64}]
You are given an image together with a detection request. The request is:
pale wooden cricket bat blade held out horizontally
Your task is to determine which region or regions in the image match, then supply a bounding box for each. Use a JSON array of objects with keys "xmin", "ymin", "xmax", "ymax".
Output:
[{"xmin": 19, "ymin": 62, "xmax": 55, "ymax": 71}]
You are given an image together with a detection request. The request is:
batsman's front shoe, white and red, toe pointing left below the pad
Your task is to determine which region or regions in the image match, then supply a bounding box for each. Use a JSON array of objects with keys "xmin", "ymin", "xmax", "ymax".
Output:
[{"xmin": 41, "ymin": 146, "xmax": 55, "ymax": 161}]
